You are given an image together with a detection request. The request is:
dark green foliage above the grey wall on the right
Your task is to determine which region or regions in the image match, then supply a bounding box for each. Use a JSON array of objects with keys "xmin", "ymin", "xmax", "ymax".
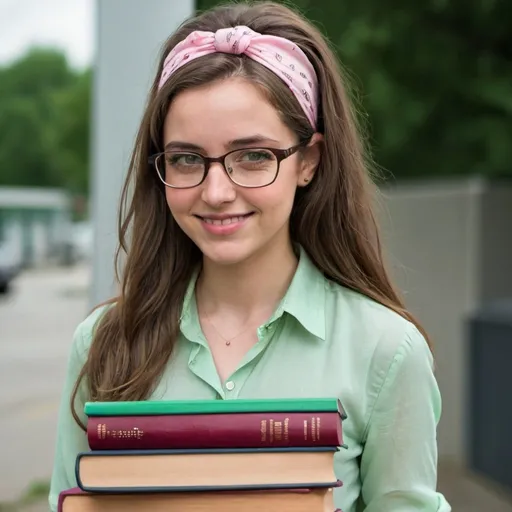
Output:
[{"xmin": 198, "ymin": 0, "xmax": 512, "ymax": 178}]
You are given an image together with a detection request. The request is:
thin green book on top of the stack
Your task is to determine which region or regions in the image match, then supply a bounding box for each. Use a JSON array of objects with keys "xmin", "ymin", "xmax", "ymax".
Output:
[{"xmin": 84, "ymin": 398, "xmax": 346, "ymax": 419}]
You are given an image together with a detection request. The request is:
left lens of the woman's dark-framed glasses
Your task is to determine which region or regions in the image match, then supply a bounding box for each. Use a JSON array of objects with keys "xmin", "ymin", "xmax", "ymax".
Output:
[{"xmin": 155, "ymin": 151, "xmax": 205, "ymax": 188}]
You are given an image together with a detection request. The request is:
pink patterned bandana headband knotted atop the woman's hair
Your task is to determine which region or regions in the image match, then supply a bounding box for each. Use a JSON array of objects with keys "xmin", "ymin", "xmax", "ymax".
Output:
[{"xmin": 158, "ymin": 26, "xmax": 318, "ymax": 130}]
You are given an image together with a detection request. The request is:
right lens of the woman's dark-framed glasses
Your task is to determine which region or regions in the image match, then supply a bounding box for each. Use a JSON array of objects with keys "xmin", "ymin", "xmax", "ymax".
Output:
[{"xmin": 225, "ymin": 148, "xmax": 278, "ymax": 187}]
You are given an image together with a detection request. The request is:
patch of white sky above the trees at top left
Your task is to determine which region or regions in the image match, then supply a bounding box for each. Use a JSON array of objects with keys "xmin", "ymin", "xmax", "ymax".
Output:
[{"xmin": 0, "ymin": 0, "xmax": 95, "ymax": 68}]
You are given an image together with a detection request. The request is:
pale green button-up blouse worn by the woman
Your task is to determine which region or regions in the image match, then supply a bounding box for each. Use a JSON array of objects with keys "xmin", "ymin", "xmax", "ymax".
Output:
[{"xmin": 49, "ymin": 246, "xmax": 451, "ymax": 512}]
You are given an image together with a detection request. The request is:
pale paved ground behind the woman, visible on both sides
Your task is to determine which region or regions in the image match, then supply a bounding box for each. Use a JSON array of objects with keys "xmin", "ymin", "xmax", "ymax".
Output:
[{"xmin": 0, "ymin": 267, "xmax": 512, "ymax": 512}]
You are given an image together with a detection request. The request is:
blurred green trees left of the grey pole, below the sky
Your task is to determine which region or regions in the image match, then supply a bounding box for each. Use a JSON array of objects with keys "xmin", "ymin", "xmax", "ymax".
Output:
[{"xmin": 0, "ymin": 49, "xmax": 91, "ymax": 195}]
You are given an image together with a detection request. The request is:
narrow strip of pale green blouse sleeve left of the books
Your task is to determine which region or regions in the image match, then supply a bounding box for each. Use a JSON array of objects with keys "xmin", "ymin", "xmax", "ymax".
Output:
[{"xmin": 48, "ymin": 315, "xmax": 96, "ymax": 512}]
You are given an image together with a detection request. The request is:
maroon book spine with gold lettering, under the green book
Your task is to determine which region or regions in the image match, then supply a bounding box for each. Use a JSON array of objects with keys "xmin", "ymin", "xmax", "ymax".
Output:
[{"xmin": 87, "ymin": 412, "xmax": 343, "ymax": 450}]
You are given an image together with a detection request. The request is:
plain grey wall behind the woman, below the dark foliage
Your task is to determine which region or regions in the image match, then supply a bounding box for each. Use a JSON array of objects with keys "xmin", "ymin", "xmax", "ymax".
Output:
[{"xmin": 381, "ymin": 178, "xmax": 512, "ymax": 465}]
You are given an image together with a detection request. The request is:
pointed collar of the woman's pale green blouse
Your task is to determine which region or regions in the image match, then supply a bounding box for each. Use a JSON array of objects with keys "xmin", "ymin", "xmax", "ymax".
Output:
[{"xmin": 180, "ymin": 246, "xmax": 325, "ymax": 340}]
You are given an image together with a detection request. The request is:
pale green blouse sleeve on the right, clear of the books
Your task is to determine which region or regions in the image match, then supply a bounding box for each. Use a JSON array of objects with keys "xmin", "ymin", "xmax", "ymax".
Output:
[{"xmin": 361, "ymin": 324, "xmax": 451, "ymax": 512}]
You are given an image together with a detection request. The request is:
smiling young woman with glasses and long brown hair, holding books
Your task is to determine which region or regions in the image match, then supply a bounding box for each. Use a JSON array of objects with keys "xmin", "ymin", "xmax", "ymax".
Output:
[{"xmin": 50, "ymin": 3, "xmax": 450, "ymax": 512}]
